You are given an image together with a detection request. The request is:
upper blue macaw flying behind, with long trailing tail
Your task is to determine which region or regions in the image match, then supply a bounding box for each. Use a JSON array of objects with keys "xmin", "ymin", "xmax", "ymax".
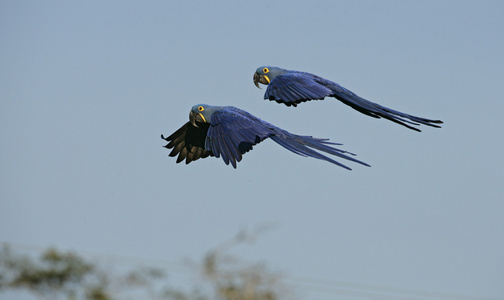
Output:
[{"xmin": 254, "ymin": 66, "xmax": 443, "ymax": 131}]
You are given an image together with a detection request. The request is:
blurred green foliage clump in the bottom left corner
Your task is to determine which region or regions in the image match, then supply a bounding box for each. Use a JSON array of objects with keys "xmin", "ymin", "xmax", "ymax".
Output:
[{"xmin": 0, "ymin": 247, "xmax": 162, "ymax": 300}]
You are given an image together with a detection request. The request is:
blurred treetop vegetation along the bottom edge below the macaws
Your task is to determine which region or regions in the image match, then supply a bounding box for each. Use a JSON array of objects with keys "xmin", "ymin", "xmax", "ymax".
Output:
[{"xmin": 0, "ymin": 233, "xmax": 284, "ymax": 300}]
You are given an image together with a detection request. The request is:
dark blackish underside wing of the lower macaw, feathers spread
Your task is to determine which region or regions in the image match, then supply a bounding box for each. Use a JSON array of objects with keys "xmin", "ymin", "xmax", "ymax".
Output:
[{"xmin": 161, "ymin": 122, "xmax": 214, "ymax": 164}]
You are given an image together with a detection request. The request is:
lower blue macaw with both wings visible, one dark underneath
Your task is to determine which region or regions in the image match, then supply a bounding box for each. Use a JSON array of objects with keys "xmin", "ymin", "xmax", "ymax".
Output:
[{"xmin": 161, "ymin": 104, "xmax": 369, "ymax": 170}]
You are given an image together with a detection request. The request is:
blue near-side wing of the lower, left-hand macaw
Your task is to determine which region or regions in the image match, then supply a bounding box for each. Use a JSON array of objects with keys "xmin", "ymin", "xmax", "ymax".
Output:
[{"xmin": 206, "ymin": 107, "xmax": 272, "ymax": 168}]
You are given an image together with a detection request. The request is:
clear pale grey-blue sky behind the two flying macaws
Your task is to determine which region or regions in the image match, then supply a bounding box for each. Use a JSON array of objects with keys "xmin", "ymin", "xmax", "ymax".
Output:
[{"xmin": 0, "ymin": 1, "xmax": 504, "ymax": 300}]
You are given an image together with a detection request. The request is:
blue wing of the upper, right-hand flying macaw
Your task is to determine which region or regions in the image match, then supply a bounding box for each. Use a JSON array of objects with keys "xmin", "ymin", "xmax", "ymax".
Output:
[{"xmin": 264, "ymin": 72, "xmax": 332, "ymax": 106}]
